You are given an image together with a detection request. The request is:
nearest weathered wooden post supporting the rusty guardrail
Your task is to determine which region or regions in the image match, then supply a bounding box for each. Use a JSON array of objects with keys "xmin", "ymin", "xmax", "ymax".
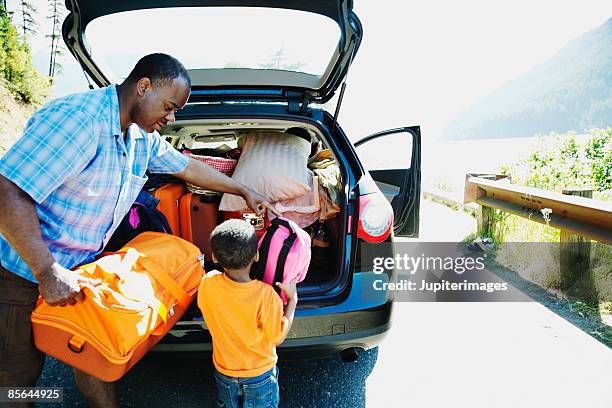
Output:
[{"xmin": 560, "ymin": 189, "xmax": 593, "ymax": 294}]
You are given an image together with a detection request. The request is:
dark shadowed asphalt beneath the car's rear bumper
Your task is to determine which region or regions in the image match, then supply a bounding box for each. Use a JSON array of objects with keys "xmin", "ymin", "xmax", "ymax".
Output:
[{"xmin": 38, "ymin": 349, "xmax": 378, "ymax": 408}]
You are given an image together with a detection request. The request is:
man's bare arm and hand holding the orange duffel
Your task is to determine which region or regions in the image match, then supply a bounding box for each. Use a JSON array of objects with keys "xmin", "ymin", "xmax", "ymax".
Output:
[{"xmin": 0, "ymin": 175, "xmax": 95, "ymax": 306}]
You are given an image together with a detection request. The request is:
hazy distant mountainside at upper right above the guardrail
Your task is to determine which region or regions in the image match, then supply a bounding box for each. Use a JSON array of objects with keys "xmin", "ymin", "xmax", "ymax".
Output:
[{"xmin": 443, "ymin": 18, "xmax": 612, "ymax": 140}]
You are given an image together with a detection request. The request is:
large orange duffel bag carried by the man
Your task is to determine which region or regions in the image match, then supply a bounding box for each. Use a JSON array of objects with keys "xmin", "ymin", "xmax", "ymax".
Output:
[{"xmin": 31, "ymin": 232, "xmax": 204, "ymax": 381}]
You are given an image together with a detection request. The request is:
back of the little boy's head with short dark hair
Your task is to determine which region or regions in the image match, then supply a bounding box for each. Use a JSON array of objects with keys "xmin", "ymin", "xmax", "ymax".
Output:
[{"xmin": 210, "ymin": 220, "xmax": 257, "ymax": 269}]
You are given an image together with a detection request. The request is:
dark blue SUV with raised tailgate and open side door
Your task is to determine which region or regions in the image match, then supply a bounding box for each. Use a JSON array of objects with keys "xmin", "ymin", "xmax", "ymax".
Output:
[{"xmin": 63, "ymin": 0, "xmax": 421, "ymax": 361}]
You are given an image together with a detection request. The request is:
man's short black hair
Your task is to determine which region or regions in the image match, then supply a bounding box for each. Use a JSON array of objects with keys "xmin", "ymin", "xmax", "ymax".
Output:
[{"xmin": 126, "ymin": 53, "xmax": 191, "ymax": 86}]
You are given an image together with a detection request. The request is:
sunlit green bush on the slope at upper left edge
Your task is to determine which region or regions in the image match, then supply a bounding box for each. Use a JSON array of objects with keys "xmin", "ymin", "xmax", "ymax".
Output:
[{"xmin": 0, "ymin": 6, "xmax": 52, "ymax": 105}]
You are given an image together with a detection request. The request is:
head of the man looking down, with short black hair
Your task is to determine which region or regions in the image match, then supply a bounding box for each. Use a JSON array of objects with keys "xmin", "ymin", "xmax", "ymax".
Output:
[{"xmin": 121, "ymin": 54, "xmax": 191, "ymax": 132}]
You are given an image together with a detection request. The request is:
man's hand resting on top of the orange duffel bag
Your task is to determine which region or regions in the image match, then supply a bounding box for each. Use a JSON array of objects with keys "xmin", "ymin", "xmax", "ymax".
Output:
[{"xmin": 38, "ymin": 262, "xmax": 100, "ymax": 306}]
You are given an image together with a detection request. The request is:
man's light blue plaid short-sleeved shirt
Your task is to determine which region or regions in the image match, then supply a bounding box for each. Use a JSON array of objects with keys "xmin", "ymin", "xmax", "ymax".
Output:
[{"xmin": 0, "ymin": 85, "xmax": 188, "ymax": 282}]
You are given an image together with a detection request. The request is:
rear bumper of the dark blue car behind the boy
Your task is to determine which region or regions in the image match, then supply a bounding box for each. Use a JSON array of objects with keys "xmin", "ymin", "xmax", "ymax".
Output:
[{"xmin": 153, "ymin": 302, "xmax": 392, "ymax": 359}]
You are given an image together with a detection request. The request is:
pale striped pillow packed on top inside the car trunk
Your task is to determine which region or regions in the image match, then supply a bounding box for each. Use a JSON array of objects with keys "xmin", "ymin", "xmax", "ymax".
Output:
[{"xmin": 219, "ymin": 132, "xmax": 312, "ymax": 211}]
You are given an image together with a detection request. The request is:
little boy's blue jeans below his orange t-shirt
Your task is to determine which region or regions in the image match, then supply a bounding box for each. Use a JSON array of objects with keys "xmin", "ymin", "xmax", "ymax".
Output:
[{"xmin": 215, "ymin": 367, "xmax": 279, "ymax": 408}]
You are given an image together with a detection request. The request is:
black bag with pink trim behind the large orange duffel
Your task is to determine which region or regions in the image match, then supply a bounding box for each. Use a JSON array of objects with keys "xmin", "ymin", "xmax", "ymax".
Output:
[{"xmin": 104, "ymin": 191, "xmax": 172, "ymax": 252}]
